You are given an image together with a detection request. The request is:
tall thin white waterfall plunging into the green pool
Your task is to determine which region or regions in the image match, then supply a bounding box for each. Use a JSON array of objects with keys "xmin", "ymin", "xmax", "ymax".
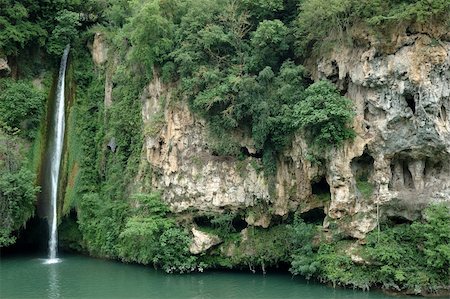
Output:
[{"xmin": 47, "ymin": 45, "xmax": 70, "ymax": 263}]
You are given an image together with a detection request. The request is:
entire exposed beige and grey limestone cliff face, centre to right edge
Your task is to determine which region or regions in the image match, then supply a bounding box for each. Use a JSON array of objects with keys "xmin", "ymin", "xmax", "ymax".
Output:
[{"xmin": 141, "ymin": 29, "xmax": 450, "ymax": 239}]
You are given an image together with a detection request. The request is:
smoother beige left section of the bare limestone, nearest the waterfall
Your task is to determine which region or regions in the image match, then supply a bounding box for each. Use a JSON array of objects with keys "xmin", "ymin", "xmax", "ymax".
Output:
[{"xmin": 142, "ymin": 76, "xmax": 270, "ymax": 212}]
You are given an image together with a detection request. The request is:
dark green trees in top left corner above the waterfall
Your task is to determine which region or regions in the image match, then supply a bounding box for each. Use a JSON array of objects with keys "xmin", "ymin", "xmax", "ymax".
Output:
[{"xmin": 0, "ymin": 0, "xmax": 104, "ymax": 56}]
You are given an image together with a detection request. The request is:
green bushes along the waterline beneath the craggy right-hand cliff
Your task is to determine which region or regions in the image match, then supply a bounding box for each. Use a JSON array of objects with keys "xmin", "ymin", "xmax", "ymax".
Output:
[{"xmin": 290, "ymin": 204, "xmax": 450, "ymax": 294}]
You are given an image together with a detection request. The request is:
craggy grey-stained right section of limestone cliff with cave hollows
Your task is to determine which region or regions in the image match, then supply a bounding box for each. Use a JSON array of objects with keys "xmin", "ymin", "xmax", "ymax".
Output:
[{"xmin": 313, "ymin": 29, "xmax": 450, "ymax": 238}]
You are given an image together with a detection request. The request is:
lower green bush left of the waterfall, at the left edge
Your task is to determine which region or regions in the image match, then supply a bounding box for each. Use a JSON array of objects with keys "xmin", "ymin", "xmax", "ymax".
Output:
[{"xmin": 0, "ymin": 130, "xmax": 39, "ymax": 247}]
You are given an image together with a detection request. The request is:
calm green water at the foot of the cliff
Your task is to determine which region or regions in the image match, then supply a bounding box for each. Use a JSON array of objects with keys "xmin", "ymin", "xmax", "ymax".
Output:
[{"xmin": 0, "ymin": 256, "xmax": 410, "ymax": 299}]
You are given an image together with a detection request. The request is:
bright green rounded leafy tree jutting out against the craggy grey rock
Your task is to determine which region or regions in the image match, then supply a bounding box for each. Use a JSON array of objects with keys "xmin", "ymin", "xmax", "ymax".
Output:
[{"xmin": 294, "ymin": 81, "xmax": 355, "ymax": 149}]
